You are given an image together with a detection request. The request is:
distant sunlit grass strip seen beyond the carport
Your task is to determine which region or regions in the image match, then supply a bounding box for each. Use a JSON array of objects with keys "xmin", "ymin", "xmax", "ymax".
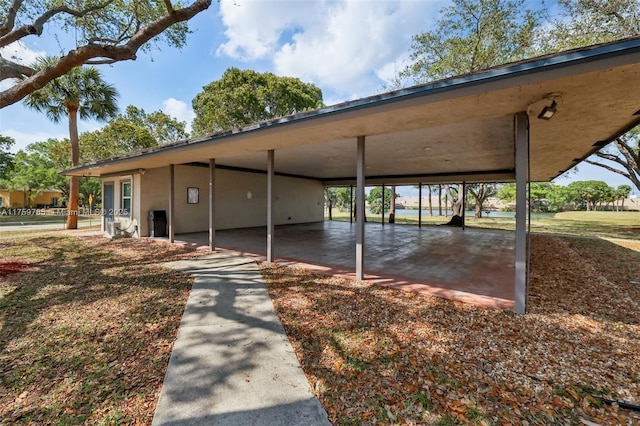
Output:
[{"xmin": 332, "ymin": 209, "xmax": 640, "ymax": 238}]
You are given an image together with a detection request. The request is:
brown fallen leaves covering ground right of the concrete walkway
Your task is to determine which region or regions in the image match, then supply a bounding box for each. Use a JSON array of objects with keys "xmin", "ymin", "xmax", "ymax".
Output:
[{"xmin": 262, "ymin": 235, "xmax": 640, "ymax": 425}]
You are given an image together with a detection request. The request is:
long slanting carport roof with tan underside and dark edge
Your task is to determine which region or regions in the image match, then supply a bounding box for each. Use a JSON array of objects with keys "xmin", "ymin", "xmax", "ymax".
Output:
[{"xmin": 63, "ymin": 37, "xmax": 640, "ymax": 184}]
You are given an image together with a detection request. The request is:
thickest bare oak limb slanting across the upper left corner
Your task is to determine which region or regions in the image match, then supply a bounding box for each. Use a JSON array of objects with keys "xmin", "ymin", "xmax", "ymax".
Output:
[{"xmin": 0, "ymin": 0, "xmax": 212, "ymax": 108}]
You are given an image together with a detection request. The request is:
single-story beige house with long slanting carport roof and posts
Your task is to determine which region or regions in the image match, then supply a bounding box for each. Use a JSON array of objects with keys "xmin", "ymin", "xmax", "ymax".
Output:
[{"xmin": 64, "ymin": 37, "xmax": 640, "ymax": 312}]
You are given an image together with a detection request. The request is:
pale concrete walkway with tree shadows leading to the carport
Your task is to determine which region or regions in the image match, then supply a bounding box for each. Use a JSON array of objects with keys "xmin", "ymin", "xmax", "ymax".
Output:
[{"xmin": 153, "ymin": 251, "xmax": 330, "ymax": 426}]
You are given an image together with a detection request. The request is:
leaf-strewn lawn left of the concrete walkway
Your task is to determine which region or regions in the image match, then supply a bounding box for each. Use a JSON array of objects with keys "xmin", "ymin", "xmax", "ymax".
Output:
[{"xmin": 0, "ymin": 234, "xmax": 198, "ymax": 425}]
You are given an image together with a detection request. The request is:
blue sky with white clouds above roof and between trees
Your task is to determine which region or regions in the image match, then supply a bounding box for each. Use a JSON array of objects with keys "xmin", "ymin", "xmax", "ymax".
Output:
[{"xmin": 0, "ymin": 0, "xmax": 629, "ymax": 194}]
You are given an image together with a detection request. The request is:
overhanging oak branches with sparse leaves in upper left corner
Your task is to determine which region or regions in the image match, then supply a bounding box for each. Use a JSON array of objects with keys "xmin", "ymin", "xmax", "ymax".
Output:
[{"xmin": 0, "ymin": 0, "xmax": 212, "ymax": 108}]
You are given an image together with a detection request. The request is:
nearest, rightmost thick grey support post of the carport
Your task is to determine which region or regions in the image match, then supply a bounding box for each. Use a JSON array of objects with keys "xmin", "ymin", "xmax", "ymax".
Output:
[{"xmin": 514, "ymin": 112, "xmax": 529, "ymax": 314}]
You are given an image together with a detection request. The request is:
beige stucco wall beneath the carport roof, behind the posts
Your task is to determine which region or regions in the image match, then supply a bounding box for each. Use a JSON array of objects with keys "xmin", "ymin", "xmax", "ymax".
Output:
[{"xmin": 134, "ymin": 165, "xmax": 324, "ymax": 236}]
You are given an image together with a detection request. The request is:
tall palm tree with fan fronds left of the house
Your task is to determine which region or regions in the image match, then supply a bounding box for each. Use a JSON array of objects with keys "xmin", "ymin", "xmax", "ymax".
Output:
[{"xmin": 24, "ymin": 57, "xmax": 118, "ymax": 229}]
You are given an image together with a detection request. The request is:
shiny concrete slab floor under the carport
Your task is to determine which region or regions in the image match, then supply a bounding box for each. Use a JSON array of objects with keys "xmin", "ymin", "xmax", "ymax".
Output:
[{"xmin": 168, "ymin": 221, "xmax": 515, "ymax": 309}]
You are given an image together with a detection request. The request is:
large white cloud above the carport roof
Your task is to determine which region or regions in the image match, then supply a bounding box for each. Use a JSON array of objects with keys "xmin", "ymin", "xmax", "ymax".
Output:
[{"xmin": 218, "ymin": 0, "xmax": 440, "ymax": 104}]
